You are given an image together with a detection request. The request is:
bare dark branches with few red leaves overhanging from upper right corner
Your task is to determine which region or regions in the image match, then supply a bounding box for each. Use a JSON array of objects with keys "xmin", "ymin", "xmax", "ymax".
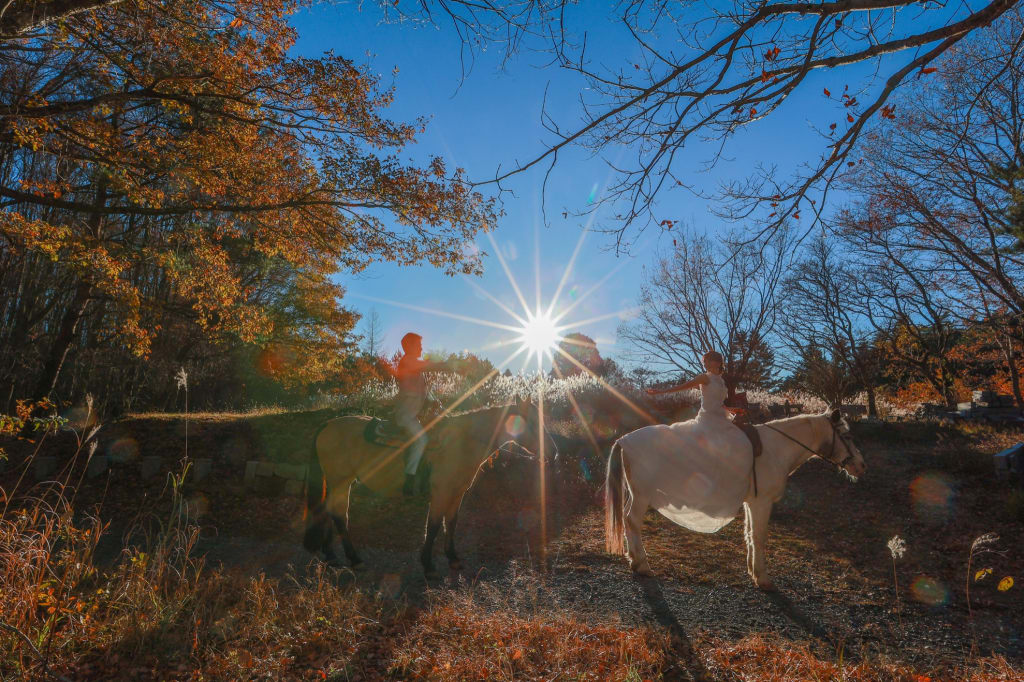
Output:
[{"xmin": 458, "ymin": 0, "xmax": 1018, "ymax": 249}]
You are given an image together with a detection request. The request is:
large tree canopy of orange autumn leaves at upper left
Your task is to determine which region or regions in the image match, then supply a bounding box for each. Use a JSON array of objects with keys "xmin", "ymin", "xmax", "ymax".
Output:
[{"xmin": 0, "ymin": 0, "xmax": 497, "ymax": 403}]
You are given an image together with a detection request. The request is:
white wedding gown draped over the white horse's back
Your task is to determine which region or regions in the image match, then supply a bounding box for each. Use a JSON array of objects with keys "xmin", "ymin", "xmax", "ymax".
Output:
[{"xmin": 618, "ymin": 374, "xmax": 753, "ymax": 532}]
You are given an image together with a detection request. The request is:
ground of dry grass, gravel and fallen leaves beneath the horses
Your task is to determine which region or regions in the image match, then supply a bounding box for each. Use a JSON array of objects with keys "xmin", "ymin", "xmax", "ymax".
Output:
[{"xmin": 0, "ymin": 405, "xmax": 1024, "ymax": 681}]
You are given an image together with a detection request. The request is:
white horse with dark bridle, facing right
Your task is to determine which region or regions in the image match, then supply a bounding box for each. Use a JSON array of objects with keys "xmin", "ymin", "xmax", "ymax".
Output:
[{"xmin": 604, "ymin": 410, "xmax": 866, "ymax": 590}]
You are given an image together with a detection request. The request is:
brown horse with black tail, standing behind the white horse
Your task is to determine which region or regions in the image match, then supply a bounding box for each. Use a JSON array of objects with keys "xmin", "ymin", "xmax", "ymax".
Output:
[{"xmin": 303, "ymin": 400, "xmax": 557, "ymax": 577}]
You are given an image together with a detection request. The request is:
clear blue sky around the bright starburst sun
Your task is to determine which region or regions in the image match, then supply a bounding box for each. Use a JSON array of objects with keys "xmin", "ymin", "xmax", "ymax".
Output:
[{"xmin": 293, "ymin": 3, "xmax": 921, "ymax": 371}]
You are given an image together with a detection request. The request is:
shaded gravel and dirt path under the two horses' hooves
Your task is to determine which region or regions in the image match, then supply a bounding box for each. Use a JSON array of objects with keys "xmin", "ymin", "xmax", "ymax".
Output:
[{"xmin": 172, "ymin": 436, "xmax": 1024, "ymax": 677}]
